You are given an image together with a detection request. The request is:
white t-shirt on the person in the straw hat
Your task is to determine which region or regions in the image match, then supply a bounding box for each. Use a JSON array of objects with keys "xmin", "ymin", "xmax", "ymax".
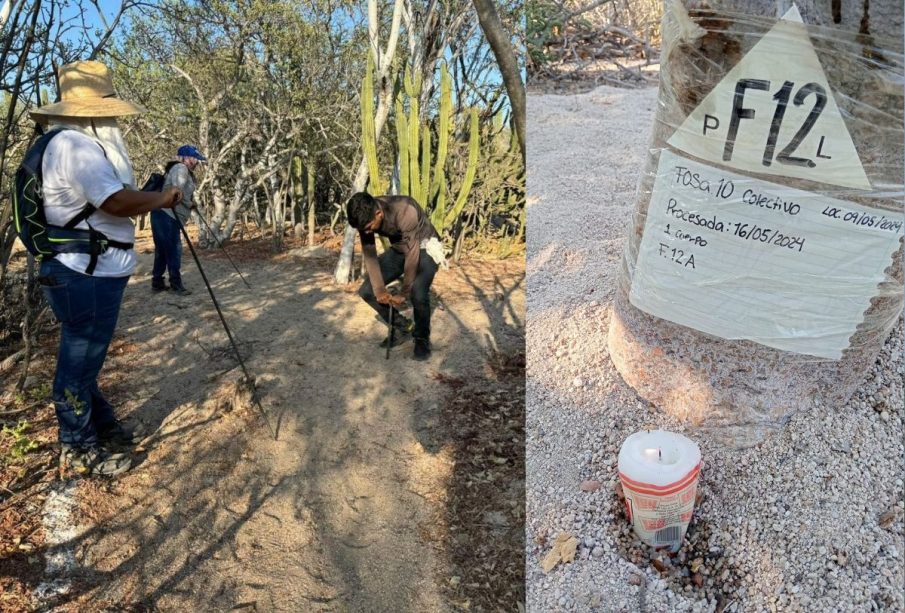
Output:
[{"xmin": 41, "ymin": 130, "xmax": 137, "ymax": 277}]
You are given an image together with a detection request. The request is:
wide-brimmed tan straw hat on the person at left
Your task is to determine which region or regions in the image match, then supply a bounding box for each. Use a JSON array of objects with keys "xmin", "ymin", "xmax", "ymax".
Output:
[{"xmin": 29, "ymin": 62, "xmax": 145, "ymax": 119}]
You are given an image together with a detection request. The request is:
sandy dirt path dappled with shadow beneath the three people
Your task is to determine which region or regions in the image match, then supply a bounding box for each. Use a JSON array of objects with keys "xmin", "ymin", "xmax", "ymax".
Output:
[{"xmin": 28, "ymin": 228, "xmax": 524, "ymax": 611}]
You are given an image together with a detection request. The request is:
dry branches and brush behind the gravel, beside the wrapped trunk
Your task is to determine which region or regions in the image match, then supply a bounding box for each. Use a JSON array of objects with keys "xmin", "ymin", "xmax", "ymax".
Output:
[{"xmin": 527, "ymin": 0, "xmax": 660, "ymax": 84}]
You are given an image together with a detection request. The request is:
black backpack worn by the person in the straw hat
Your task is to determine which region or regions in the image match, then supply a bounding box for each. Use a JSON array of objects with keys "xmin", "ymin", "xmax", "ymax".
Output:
[{"xmin": 12, "ymin": 130, "xmax": 133, "ymax": 275}]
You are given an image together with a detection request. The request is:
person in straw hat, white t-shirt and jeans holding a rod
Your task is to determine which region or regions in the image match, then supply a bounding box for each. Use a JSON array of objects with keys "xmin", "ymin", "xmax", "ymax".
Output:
[{"xmin": 30, "ymin": 61, "xmax": 182, "ymax": 476}]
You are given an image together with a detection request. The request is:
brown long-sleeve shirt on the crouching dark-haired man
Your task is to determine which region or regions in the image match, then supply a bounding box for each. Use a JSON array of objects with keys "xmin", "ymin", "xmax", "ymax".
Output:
[{"xmin": 358, "ymin": 196, "xmax": 439, "ymax": 296}]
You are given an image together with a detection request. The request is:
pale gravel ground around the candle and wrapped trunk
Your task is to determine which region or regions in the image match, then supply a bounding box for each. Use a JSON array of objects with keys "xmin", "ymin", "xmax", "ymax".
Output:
[{"xmin": 526, "ymin": 87, "xmax": 905, "ymax": 611}]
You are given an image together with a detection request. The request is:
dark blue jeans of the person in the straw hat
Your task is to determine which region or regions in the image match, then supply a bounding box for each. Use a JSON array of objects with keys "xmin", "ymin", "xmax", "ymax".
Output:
[{"xmin": 40, "ymin": 259, "xmax": 129, "ymax": 446}]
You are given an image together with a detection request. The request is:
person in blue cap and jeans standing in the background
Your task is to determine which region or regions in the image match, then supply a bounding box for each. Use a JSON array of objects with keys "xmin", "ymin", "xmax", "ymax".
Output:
[{"xmin": 151, "ymin": 145, "xmax": 207, "ymax": 296}]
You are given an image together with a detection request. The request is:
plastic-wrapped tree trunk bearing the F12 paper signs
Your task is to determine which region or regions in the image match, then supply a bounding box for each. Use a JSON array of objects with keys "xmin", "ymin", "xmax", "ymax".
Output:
[{"xmin": 608, "ymin": 0, "xmax": 903, "ymax": 446}]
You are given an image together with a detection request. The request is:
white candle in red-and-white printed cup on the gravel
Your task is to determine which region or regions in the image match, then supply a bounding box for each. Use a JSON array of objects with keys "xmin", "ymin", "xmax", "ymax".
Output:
[{"xmin": 619, "ymin": 430, "xmax": 701, "ymax": 551}]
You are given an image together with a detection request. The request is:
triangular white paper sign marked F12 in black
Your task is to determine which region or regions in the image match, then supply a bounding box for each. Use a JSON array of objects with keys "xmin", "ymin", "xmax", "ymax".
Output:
[{"xmin": 668, "ymin": 6, "xmax": 871, "ymax": 190}]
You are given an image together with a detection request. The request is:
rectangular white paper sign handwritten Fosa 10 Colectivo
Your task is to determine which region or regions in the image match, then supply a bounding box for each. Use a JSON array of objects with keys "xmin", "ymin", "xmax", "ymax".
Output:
[{"xmin": 630, "ymin": 150, "xmax": 905, "ymax": 359}]
